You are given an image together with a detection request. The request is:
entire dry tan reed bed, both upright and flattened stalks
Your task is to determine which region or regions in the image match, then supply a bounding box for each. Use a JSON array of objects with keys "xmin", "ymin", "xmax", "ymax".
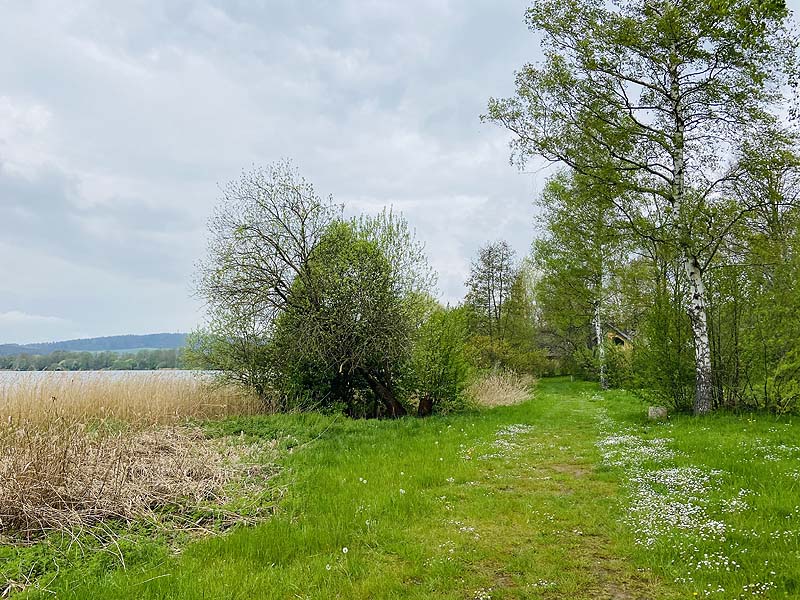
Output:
[{"xmin": 0, "ymin": 373, "xmax": 276, "ymax": 540}]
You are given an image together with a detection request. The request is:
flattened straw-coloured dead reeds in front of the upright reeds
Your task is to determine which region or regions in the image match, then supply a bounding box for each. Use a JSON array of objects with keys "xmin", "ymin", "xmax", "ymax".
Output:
[{"xmin": 0, "ymin": 418, "xmax": 277, "ymax": 540}]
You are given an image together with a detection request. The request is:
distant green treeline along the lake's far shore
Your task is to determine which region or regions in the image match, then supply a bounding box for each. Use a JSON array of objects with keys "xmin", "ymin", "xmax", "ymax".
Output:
[{"xmin": 0, "ymin": 348, "xmax": 184, "ymax": 371}]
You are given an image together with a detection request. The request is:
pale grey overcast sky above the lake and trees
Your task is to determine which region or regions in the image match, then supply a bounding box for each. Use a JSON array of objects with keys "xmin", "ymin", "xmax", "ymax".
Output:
[{"xmin": 0, "ymin": 0, "xmax": 800, "ymax": 343}]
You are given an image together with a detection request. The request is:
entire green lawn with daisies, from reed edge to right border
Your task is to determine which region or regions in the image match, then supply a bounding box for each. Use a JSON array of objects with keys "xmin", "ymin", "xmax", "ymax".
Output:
[{"xmin": 6, "ymin": 380, "xmax": 800, "ymax": 600}]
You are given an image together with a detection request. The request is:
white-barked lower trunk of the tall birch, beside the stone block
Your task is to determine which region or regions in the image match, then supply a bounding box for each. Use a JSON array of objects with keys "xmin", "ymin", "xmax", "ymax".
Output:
[{"xmin": 684, "ymin": 257, "xmax": 714, "ymax": 415}]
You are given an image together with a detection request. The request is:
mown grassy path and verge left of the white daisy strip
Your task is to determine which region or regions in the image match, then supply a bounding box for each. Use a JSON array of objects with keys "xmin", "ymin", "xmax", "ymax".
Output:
[{"xmin": 21, "ymin": 382, "xmax": 686, "ymax": 600}]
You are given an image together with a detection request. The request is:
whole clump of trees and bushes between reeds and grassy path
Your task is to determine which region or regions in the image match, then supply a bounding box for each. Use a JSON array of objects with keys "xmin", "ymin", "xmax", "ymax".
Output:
[{"xmin": 186, "ymin": 163, "xmax": 494, "ymax": 417}]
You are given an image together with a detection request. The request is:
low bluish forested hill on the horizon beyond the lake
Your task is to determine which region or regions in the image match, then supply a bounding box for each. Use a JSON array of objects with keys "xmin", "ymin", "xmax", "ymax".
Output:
[{"xmin": 0, "ymin": 333, "xmax": 186, "ymax": 356}]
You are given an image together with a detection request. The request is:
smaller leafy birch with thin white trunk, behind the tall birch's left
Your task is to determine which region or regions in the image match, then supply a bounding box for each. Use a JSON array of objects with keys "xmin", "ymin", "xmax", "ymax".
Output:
[{"xmin": 533, "ymin": 171, "xmax": 636, "ymax": 385}]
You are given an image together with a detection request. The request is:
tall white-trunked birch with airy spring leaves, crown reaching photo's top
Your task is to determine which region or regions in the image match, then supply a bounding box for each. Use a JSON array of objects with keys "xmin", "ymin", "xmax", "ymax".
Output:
[{"xmin": 486, "ymin": 0, "xmax": 796, "ymax": 414}]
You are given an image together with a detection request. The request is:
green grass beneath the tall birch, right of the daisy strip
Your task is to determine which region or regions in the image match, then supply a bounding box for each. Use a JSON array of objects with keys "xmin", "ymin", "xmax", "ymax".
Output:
[{"xmin": 604, "ymin": 392, "xmax": 800, "ymax": 598}]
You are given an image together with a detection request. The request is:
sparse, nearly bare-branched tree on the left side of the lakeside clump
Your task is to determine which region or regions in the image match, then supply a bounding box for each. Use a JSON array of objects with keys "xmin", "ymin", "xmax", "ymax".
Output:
[{"xmin": 195, "ymin": 161, "xmax": 341, "ymax": 409}]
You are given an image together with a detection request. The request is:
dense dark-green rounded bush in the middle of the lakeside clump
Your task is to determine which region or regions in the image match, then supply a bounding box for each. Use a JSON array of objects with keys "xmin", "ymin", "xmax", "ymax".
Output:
[{"xmin": 274, "ymin": 221, "xmax": 411, "ymax": 416}]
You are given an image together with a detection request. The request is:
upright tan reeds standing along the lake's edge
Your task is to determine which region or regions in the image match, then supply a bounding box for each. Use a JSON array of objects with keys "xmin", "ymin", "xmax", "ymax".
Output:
[{"xmin": 0, "ymin": 371, "xmax": 261, "ymax": 425}]
